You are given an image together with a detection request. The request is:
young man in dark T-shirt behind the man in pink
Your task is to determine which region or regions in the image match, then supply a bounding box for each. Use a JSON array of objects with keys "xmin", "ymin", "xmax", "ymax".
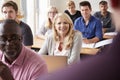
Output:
[{"xmin": 1, "ymin": 0, "xmax": 33, "ymax": 48}]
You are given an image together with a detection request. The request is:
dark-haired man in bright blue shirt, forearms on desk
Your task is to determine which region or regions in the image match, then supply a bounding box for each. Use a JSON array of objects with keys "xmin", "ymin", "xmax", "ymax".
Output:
[{"xmin": 74, "ymin": 1, "xmax": 103, "ymax": 43}]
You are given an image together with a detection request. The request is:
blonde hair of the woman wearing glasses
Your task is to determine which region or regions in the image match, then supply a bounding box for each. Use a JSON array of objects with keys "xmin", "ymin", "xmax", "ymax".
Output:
[{"xmin": 45, "ymin": 6, "xmax": 58, "ymax": 29}]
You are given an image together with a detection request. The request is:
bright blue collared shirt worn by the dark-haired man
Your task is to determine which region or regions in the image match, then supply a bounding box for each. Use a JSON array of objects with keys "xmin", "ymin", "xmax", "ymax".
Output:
[{"xmin": 74, "ymin": 16, "xmax": 103, "ymax": 40}]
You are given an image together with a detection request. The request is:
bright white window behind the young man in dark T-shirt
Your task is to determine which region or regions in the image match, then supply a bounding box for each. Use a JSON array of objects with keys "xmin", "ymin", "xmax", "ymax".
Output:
[{"xmin": 21, "ymin": 0, "xmax": 49, "ymax": 35}]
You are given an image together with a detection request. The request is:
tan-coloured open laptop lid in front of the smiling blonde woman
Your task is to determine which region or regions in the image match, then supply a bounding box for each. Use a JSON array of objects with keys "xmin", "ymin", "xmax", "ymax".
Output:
[{"xmin": 42, "ymin": 55, "xmax": 67, "ymax": 72}]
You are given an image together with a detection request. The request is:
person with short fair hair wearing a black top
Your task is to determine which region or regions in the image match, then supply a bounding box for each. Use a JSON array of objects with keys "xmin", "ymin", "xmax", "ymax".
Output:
[{"xmin": 64, "ymin": 1, "xmax": 81, "ymax": 23}]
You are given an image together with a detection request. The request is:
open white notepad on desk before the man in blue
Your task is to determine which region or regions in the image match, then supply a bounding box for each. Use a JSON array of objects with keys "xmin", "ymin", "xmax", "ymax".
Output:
[{"xmin": 82, "ymin": 39, "xmax": 112, "ymax": 48}]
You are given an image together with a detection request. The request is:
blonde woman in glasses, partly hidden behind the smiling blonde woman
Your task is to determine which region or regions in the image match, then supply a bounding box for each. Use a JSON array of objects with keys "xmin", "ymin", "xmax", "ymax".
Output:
[{"xmin": 37, "ymin": 6, "xmax": 58, "ymax": 39}]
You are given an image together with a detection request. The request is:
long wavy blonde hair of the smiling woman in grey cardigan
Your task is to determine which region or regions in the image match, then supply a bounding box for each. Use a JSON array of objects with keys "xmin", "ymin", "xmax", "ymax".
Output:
[{"xmin": 53, "ymin": 13, "xmax": 75, "ymax": 49}]
